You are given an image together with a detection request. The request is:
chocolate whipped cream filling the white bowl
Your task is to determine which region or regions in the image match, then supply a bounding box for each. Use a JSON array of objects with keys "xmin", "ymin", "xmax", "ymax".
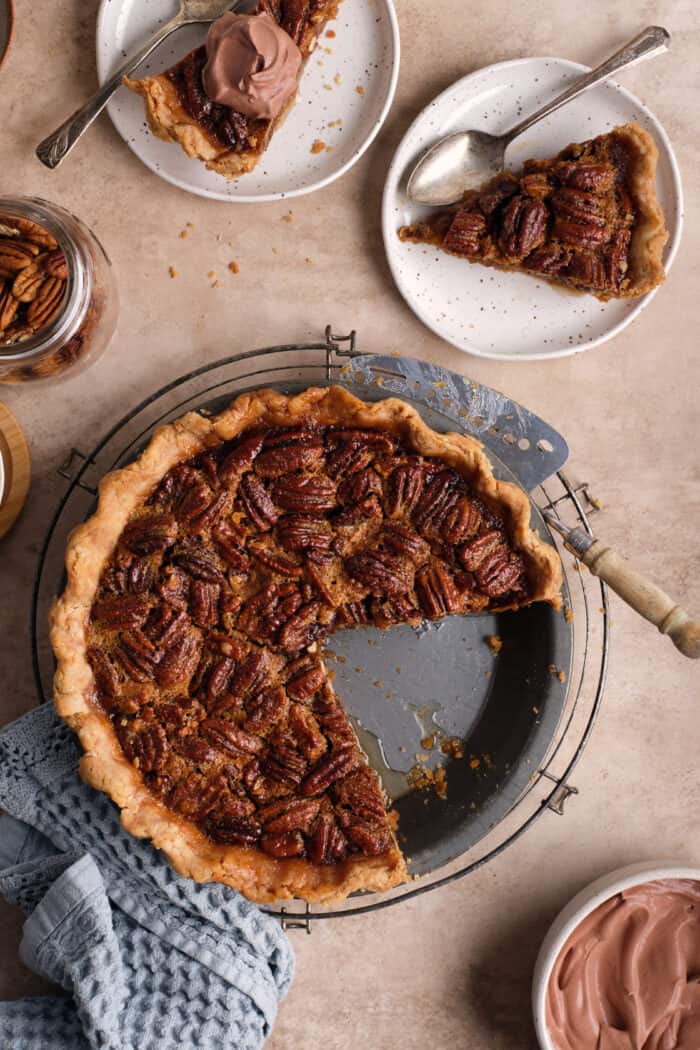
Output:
[{"xmin": 547, "ymin": 879, "xmax": 700, "ymax": 1050}]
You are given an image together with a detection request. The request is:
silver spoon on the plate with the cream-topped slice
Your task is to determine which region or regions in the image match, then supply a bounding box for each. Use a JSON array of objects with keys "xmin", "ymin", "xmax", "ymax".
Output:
[{"xmin": 37, "ymin": 0, "xmax": 251, "ymax": 168}]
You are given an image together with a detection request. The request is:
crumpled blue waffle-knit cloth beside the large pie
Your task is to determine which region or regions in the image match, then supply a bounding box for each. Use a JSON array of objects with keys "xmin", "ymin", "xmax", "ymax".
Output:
[{"xmin": 0, "ymin": 705, "xmax": 294, "ymax": 1050}]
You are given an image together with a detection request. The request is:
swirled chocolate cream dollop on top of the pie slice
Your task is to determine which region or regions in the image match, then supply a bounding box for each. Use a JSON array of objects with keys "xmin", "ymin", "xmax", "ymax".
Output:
[{"xmin": 203, "ymin": 12, "xmax": 301, "ymax": 120}]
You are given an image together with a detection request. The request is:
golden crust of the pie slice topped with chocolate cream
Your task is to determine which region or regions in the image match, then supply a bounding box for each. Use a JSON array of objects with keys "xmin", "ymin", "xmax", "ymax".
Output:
[{"xmin": 124, "ymin": 0, "xmax": 340, "ymax": 179}]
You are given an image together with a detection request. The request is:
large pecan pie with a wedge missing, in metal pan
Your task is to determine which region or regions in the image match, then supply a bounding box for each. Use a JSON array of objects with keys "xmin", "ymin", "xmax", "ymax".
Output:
[{"xmin": 51, "ymin": 387, "xmax": 560, "ymax": 902}]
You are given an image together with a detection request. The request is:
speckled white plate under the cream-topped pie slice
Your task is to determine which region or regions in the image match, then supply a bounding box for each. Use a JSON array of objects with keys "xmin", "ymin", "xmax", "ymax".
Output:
[{"xmin": 97, "ymin": 0, "xmax": 400, "ymax": 202}]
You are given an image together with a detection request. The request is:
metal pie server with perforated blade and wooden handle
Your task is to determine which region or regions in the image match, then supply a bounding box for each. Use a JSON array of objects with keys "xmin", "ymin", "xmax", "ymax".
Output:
[{"xmin": 348, "ymin": 355, "xmax": 700, "ymax": 659}]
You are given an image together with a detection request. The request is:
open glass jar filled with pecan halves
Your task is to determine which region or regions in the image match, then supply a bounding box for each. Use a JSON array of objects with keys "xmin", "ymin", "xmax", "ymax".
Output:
[{"xmin": 0, "ymin": 197, "xmax": 119, "ymax": 383}]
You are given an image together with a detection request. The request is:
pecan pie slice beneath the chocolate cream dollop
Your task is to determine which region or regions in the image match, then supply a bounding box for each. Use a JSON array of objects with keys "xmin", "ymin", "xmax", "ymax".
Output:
[{"xmin": 124, "ymin": 0, "xmax": 340, "ymax": 179}]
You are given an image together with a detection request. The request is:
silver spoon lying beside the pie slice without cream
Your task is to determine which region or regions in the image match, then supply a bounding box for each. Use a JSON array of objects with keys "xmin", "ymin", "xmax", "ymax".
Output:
[{"xmin": 407, "ymin": 25, "xmax": 671, "ymax": 205}]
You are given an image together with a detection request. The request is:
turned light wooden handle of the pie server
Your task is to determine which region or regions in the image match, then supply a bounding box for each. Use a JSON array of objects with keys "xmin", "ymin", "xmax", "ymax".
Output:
[{"xmin": 581, "ymin": 540, "xmax": 700, "ymax": 659}]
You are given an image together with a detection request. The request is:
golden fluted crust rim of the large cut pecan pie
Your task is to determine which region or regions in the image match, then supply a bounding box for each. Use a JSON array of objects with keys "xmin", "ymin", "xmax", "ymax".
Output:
[{"xmin": 50, "ymin": 386, "xmax": 561, "ymax": 903}]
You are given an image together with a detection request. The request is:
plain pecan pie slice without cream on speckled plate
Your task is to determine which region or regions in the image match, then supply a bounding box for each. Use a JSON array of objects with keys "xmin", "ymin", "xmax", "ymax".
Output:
[{"xmin": 399, "ymin": 124, "xmax": 669, "ymax": 299}]
